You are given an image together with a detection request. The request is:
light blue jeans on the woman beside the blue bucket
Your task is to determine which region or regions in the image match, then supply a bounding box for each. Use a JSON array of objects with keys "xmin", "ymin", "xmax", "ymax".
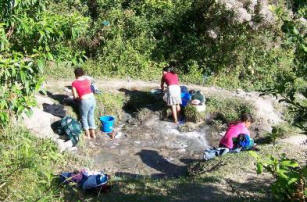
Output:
[{"xmin": 80, "ymin": 95, "xmax": 96, "ymax": 130}]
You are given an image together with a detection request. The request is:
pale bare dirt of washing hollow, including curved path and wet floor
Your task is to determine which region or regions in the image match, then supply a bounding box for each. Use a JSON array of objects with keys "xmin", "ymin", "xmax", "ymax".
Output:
[{"xmin": 25, "ymin": 80, "xmax": 307, "ymax": 200}]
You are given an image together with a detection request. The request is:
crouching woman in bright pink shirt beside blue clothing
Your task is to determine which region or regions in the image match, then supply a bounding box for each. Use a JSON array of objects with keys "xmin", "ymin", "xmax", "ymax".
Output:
[{"xmin": 220, "ymin": 113, "xmax": 253, "ymax": 149}]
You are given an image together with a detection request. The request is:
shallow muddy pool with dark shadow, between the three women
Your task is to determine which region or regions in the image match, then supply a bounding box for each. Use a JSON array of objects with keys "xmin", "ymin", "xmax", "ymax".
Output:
[{"xmin": 78, "ymin": 115, "xmax": 214, "ymax": 177}]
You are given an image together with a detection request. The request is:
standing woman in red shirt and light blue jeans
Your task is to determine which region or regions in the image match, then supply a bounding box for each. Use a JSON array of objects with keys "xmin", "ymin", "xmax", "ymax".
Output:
[{"xmin": 72, "ymin": 68, "xmax": 96, "ymax": 138}]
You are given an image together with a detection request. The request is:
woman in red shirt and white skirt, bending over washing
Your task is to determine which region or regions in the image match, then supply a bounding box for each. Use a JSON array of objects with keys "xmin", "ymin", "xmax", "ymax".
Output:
[{"xmin": 161, "ymin": 66, "xmax": 182, "ymax": 123}]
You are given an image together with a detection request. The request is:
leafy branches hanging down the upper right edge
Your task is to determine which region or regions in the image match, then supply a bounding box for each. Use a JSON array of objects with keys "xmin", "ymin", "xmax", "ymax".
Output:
[{"xmin": 265, "ymin": 1, "xmax": 307, "ymax": 133}]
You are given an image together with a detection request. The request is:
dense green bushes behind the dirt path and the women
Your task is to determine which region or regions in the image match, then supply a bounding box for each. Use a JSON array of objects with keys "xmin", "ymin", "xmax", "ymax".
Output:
[{"xmin": 0, "ymin": 0, "xmax": 306, "ymax": 124}]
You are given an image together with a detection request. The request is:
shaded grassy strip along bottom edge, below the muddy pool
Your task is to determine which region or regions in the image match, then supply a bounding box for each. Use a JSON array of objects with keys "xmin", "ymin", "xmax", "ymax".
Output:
[{"xmin": 58, "ymin": 174, "xmax": 272, "ymax": 201}]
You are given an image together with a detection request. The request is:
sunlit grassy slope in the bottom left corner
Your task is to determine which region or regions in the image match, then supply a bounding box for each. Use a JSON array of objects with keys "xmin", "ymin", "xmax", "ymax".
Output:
[{"xmin": 0, "ymin": 127, "xmax": 67, "ymax": 201}]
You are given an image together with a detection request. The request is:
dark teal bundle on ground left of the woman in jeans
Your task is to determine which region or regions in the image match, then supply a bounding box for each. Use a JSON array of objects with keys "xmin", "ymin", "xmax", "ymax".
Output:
[{"xmin": 57, "ymin": 116, "xmax": 82, "ymax": 146}]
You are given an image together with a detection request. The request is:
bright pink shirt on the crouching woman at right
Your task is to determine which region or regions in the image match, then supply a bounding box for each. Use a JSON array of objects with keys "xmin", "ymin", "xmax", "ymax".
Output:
[{"xmin": 220, "ymin": 122, "xmax": 250, "ymax": 149}]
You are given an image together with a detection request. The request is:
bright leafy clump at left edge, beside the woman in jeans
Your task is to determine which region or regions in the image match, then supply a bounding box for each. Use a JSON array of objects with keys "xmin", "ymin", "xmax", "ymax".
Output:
[{"xmin": 0, "ymin": 52, "xmax": 43, "ymax": 126}]
